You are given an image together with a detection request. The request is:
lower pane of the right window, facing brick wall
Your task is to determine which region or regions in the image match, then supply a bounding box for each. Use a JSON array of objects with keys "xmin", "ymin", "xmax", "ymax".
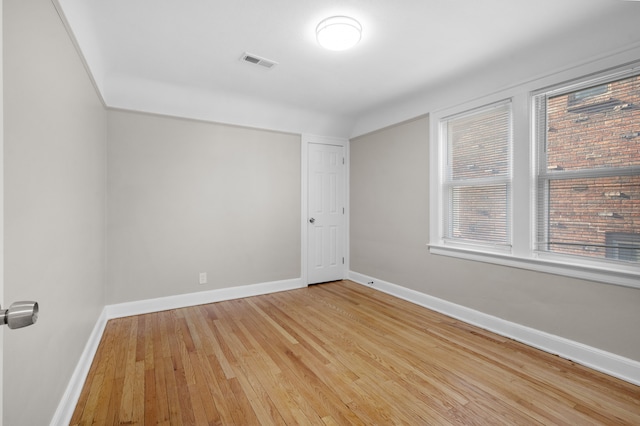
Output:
[{"xmin": 538, "ymin": 175, "xmax": 640, "ymax": 262}]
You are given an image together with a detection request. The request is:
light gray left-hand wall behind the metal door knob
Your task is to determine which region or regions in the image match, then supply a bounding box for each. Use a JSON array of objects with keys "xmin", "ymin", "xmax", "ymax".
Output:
[{"xmin": 3, "ymin": 0, "xmax": 106, "ymax": 425}]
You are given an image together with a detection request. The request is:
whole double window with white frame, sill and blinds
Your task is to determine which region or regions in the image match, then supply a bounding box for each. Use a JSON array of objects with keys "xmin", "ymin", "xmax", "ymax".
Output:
[{"xmin": 429, "ymin": 64, "xmax": 640, "ymax": 288}]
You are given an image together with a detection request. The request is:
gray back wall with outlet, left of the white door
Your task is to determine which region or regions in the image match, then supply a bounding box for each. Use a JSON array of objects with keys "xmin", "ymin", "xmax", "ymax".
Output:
[{"xmin": 107, "ymin": 111, "xmax": 300, "ymax": 304}]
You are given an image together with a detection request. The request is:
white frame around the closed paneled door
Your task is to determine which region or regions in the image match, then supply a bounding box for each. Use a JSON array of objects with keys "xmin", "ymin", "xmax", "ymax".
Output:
[{"xmin": 302, "ymin": 133, "xmax": 350, "ymax": 286}]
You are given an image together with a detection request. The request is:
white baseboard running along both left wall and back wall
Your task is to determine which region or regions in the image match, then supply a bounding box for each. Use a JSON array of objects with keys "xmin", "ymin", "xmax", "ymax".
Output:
[{"xmin": 50, "ymin": 278, "xmax": 306, "ymax": 426}]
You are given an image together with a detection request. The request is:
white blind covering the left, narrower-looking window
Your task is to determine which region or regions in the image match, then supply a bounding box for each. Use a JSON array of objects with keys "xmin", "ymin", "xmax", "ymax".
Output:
[{"xmin": 441, "ymin": 101, "xmax": 512, "ymax": 247}]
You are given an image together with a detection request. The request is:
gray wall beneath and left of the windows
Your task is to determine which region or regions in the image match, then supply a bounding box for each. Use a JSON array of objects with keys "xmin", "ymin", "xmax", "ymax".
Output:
[{"xmin": 350, "ymin": 117, "xmax": 640, "ymax": 361}]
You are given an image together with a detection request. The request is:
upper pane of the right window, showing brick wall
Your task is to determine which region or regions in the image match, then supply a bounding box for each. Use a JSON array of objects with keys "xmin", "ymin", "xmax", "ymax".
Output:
[{"xmin": 546, "ymin": 76, "xmax": 640, "ymax": 172}]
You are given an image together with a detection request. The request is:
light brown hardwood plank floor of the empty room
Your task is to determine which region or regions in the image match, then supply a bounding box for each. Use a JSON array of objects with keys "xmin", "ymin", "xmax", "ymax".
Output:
[{"xmin": 71, "ymin": 281, "xmax": 640, "ymax": 425}]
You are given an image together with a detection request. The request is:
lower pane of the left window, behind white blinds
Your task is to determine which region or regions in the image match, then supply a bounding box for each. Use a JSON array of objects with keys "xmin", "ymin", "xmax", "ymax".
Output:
[{"xmin": 445, "ymin": 184, "xmax": 510, "ymax": 244}]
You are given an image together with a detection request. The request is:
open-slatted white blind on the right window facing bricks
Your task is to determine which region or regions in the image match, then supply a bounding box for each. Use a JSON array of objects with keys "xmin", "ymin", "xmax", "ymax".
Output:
[{"xmin": 534, "ymin": 70, "xmax": 640, "ymax": 263}]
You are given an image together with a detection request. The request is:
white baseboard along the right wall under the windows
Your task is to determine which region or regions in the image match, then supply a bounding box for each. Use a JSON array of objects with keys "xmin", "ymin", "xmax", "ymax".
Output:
[{"xmin": 349, "ymin": 271, "xmax": 640, "ymax": 386}]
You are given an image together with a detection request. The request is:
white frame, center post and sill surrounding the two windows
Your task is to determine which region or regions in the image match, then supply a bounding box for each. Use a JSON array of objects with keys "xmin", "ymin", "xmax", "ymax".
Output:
[{"xmin": 427, "ymin": 61, "xmax": 640, "ymax": 288}]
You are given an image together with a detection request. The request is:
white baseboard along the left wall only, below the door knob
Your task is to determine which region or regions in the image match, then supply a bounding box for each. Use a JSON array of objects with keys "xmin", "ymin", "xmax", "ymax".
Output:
[{"xmin": 51, "ymin": 308, "xmax": 108, "ymax": 426}]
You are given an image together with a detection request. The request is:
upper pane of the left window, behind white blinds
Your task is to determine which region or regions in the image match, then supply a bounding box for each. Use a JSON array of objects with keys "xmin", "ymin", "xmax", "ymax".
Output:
[{"xmin": 447, "ymin": 104, "xmax": 511, "ymax": 180}]
